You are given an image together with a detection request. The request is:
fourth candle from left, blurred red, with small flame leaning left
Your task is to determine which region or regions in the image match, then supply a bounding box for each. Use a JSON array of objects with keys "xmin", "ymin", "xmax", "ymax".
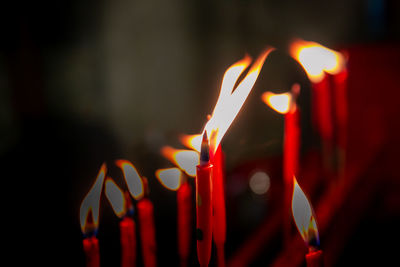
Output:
[{"xmin": 156, "ymin": 168, "xmax": 192, "ymax": 266}]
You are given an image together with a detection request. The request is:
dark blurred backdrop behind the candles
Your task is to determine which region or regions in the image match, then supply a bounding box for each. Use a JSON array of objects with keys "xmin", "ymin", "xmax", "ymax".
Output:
[{"xmin": 0, "ymin": 0, "xmax": 400, "ymax": 266}]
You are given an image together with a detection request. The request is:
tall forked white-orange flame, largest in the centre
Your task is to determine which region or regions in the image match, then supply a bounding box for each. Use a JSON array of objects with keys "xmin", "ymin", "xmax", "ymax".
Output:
[{"xmin": 201, "ymin": 48, "xmax": 273, "ymax": 153}]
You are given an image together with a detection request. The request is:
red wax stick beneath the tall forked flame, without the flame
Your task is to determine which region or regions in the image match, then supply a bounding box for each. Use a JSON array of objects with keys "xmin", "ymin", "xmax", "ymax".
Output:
[{"xmin": 211, "ymin": 145, "xmax": 226, "ymax": 267}]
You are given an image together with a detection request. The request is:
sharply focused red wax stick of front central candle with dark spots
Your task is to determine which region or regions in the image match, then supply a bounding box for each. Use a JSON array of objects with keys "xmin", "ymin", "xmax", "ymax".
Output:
[{"xmin": 196, "ymin": 164, "xmax": 213, "ymax": 266}]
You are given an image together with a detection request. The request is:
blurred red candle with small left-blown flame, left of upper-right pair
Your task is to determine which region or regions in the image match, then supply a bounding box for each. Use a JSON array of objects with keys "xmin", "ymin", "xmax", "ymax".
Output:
[{"xmin": 261, "ymin": 84, "xmax": 301, "ymax": 245}]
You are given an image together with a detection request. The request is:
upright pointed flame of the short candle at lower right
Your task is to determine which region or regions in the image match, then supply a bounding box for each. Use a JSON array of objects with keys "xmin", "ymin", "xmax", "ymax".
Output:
[{"xmin": 292, "ymin": 177, "xmax": 319, "ymax": 248}]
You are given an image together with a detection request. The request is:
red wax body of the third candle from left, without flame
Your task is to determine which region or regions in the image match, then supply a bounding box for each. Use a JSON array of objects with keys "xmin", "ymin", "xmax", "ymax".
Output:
[{"xmin": 136, "ymin": 198, "xmax": 157, "ymax": 267}]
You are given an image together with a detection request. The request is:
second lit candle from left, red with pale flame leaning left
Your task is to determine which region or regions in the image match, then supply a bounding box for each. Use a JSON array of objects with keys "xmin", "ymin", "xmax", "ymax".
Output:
[{"xmin": 105, "ymin": 177, "xmax": 136, "ymax": 267}]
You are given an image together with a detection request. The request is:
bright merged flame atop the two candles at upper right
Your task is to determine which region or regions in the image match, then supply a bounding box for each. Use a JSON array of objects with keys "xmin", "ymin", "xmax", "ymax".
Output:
[{"xmin": 290, "ymin": 40, "xmax": 346, "ymax": 83}]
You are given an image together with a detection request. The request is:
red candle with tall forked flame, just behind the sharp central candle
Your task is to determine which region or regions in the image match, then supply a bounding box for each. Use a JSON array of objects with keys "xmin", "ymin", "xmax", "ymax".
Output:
[{"xmin": 183, "ymin": 48, "xmax": 273, "ymax": 267}]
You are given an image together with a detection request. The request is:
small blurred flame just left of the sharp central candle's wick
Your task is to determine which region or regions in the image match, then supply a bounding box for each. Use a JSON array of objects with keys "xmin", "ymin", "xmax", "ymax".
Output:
[{"xmin": 161, "ymin": 146, "xmax": 200, "ymax": 177}]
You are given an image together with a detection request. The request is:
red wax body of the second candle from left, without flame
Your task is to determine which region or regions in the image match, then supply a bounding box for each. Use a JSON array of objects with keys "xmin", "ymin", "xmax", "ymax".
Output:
[{"xmin": 119, "ymin": 217, "xmax": 136, "ymax": 267}]
